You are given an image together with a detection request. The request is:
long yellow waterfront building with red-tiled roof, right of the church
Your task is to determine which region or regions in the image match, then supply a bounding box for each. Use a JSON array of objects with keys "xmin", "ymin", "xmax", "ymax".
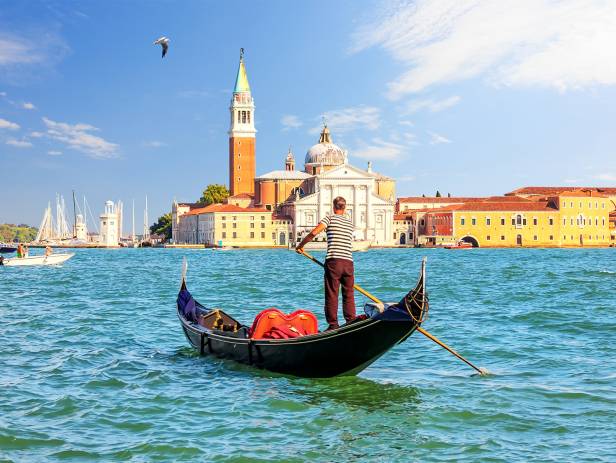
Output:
[{"xmin": 420, "ymin": 191, "xmax": 612, "ymax": 247}]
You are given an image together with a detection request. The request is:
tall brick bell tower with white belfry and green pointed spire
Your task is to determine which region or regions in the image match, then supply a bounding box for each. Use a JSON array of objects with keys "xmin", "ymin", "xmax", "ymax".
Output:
[{"xmin": 229, "ymin": 48, "xmax": 257, "ymax": 196}]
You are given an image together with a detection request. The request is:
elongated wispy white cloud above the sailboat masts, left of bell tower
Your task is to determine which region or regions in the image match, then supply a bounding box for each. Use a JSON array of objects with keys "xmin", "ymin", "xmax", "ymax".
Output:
[{"xmin": 43, "ymin": 117, "xmax": 118, "ymax": 159}]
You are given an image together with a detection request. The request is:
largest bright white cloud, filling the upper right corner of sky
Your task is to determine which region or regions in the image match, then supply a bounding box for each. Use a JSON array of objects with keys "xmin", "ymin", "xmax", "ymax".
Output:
[{"xmin": 353, "ymin": 0, "xmax": 616, "ymax": 99}]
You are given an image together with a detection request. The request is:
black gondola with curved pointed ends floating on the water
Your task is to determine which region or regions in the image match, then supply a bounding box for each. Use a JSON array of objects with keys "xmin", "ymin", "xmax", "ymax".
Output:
[{"xmin": 177, "ymin": 259, "xmax": 428, "ymax": 378}]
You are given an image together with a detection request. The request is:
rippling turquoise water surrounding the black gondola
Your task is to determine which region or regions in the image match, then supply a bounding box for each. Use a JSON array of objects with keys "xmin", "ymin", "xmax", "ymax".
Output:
[{"xmin": 0, "ymin": 249, "xmax": 616, "ymax": 462}]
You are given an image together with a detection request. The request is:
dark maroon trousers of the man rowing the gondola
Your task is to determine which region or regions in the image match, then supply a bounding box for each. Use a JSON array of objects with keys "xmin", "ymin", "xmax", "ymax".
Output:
[{"xmin": 324, "ymin": 259, "xmax": 355, "ymax": 327}]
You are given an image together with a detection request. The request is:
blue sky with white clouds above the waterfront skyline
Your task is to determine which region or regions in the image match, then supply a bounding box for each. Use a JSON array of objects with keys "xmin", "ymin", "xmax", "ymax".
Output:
[{"xmin": 0, "ymin": 0, "xmax": 616, "ymax": 226}]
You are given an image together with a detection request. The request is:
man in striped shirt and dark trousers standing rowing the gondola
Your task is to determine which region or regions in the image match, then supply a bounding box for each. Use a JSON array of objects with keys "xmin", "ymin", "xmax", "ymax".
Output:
[{"xmin": 296, "ymin": 196, "xmax": 355, "ymax": 330}]
